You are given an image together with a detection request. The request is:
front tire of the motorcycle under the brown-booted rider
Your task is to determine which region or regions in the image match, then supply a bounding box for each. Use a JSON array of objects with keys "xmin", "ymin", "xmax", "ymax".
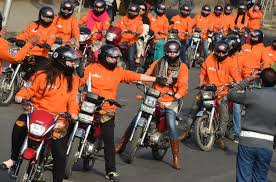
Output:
[{"xmin": 123, "ymin": 126, "xmax": 143, "ymax": 164}]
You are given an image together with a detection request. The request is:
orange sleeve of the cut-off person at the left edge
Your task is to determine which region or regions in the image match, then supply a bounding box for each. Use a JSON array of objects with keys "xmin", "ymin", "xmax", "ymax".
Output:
[{"xmin": 0, "ymin": 37, "xmax": 33, "ymax": 64}]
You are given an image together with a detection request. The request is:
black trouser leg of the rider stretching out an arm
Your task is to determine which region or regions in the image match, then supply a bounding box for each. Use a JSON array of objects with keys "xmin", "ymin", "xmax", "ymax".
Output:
[{"xmin": 101, "ymin": 117, "xmax": 116, "ymax": 174}]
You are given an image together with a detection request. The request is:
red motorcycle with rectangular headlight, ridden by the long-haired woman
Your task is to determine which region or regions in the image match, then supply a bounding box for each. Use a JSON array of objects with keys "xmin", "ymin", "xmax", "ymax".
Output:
[{"xmin": 11, "ymin": 101, "xmax": 71, "ymax": 182}]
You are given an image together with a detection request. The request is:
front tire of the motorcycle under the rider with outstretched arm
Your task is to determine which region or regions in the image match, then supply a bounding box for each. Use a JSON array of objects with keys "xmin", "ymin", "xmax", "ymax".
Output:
[{"xmin": 64, "ymin": 137, "xmax": 81, "ymax": 179}]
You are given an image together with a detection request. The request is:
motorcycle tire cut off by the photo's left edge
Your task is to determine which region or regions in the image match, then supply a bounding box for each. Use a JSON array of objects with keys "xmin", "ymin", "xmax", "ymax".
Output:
[{"xmin": 0, "ymin": 73, "xmax": 16, "ymax": 106}]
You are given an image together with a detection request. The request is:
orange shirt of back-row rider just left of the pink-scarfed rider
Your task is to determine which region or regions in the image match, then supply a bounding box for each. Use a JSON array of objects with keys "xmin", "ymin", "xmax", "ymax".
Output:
[{"xmin": 53, "ymin": 16, "xmax": 80, "ymax": 42}]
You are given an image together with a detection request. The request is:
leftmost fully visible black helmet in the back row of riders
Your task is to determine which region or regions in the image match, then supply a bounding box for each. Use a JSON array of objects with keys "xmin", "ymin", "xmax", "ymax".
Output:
[{"xmin": 38, "ymin": 6, "xmax": 55, "ymax": 27}]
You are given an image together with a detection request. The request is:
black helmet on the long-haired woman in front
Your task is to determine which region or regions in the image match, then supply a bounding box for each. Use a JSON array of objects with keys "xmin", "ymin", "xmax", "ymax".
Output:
[{"xmin": 52, "ymin": 46, "xmax": 82, "ymax": 75}]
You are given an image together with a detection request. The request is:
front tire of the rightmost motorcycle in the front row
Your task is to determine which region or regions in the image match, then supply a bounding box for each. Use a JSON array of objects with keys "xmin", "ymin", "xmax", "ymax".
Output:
[{"xmin": 195, "ymin": 115, "xmax": 215, "ymax": 151}]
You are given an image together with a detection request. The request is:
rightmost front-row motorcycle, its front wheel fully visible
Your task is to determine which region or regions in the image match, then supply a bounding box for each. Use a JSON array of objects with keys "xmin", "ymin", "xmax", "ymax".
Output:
[{"xmin": 194, "ymin": 84, "xmax": 230, "ymax": 151}]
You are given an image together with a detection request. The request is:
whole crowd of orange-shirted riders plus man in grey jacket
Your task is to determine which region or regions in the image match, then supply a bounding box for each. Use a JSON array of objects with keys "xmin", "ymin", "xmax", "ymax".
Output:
[{"xmin": 0, "ymin": 0, "xmax": 276, "ymax": 182}]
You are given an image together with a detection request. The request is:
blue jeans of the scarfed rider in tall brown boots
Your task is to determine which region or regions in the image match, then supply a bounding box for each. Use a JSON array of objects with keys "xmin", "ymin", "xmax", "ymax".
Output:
[{"xmin": 127, "ymin": 108, "xmax": 178, "ymax": 140}]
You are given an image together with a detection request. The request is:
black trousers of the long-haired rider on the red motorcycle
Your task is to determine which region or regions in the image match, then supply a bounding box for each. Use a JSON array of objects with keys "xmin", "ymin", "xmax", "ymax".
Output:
[{"xmin": 11, "ymin": 114, "xmax": 67, "ymax": 182}]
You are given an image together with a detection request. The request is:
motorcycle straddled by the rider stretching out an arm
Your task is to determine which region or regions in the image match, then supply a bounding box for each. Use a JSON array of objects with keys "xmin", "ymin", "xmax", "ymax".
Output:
[{"xmin": 65, "ymin": 91, "xmax": 122, "ymax": 179}]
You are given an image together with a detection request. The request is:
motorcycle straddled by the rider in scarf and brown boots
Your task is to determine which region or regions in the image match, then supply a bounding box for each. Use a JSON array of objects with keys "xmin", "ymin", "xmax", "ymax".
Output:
[{"xmin": 122, "ymin": 83, "xmax": 182, "ymax": 164}]
